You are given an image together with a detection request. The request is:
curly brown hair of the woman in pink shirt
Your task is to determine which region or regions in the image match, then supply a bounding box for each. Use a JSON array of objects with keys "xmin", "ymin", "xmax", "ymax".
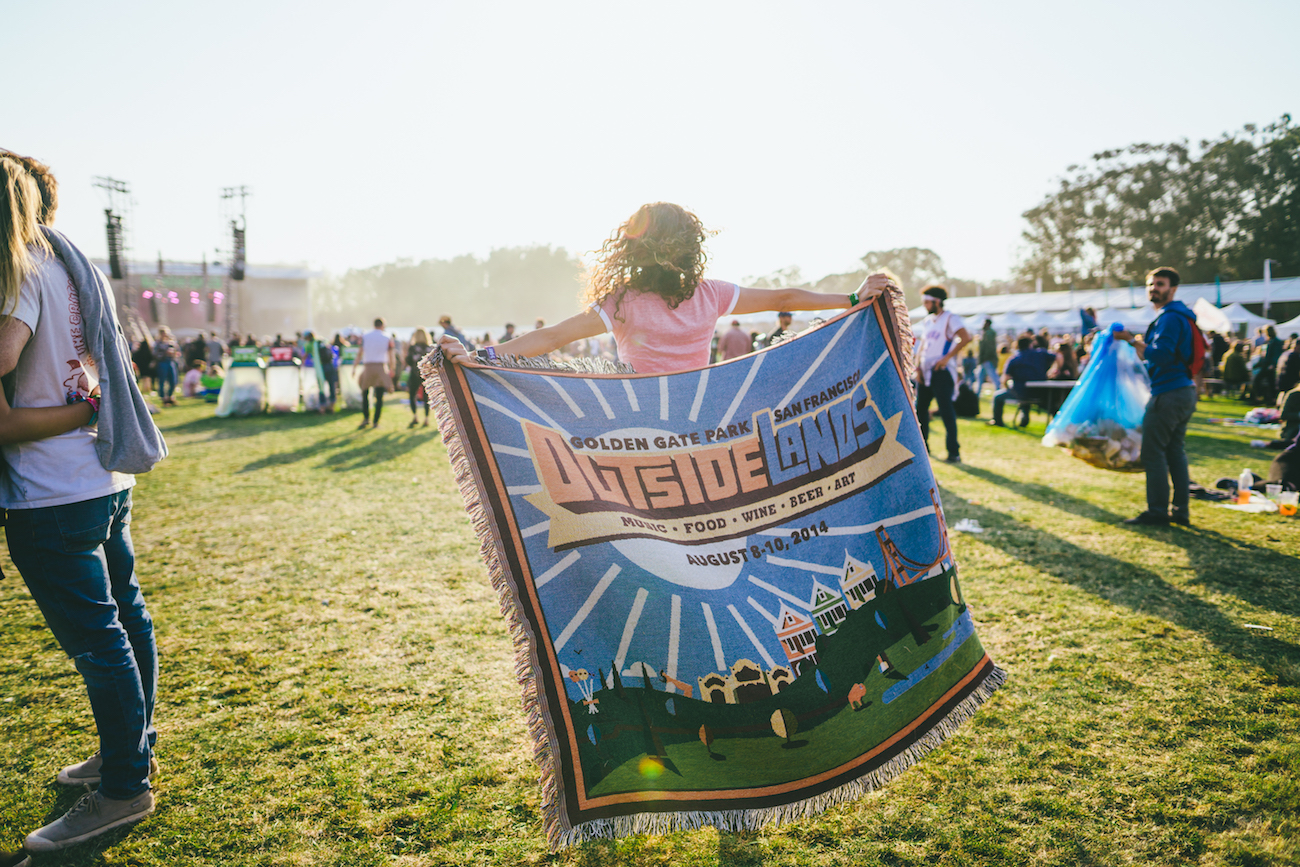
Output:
[{"xmin": 582, "ymin": 201, "xmax": 714, "ymax": 317}]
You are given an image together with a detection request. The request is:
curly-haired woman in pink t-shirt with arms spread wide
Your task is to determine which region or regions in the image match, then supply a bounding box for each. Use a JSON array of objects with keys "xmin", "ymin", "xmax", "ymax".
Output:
[{"xmin": 438, "ymin": 201, "xmax": 893, "ymax": 373}]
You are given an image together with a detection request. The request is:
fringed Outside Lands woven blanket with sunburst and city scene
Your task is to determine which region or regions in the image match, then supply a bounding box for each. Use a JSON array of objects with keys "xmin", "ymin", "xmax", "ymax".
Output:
[{"xmin": 423, "ymin": 291, "xmax": 1004, "ymax": 848}]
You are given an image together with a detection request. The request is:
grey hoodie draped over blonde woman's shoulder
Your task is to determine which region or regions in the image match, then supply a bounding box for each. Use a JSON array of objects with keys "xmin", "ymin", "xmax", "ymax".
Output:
[{"xmin": 40, "ymin": 226, "xmax": 166, "ymax": 473}]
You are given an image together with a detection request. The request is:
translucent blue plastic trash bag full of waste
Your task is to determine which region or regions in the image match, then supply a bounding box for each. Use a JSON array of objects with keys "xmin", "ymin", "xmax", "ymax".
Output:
[{"xmin": 1043, "ymin": 322, "xmax": 1151, "ymax": 472}]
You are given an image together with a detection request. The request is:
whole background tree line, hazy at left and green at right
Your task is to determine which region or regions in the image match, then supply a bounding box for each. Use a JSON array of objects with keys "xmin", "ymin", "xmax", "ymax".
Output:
[{"xmin": 315, "ymin": 114, "xmax": 1300, "ymax": 328}]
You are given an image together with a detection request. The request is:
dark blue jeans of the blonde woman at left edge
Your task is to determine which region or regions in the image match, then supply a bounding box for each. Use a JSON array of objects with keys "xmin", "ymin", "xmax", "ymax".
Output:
[{"xmin": 5, "ymin": 490, "xmax": 157, "ymax": 799}]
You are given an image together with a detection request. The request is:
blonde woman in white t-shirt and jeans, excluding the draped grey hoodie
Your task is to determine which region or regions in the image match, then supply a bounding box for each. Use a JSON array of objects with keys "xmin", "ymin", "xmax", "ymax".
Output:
[{"xmin": 0, "ymin": 156, "xmax": 157, "ymax": 853}]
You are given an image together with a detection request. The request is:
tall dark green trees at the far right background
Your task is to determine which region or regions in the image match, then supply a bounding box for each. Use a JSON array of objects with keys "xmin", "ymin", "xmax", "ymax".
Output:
[{"xmin": 1015, "ymin": 114, "xmax": 1300, "ymax": 289}]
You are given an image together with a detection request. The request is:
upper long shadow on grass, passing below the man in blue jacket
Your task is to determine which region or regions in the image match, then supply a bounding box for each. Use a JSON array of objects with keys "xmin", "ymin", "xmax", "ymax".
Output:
[{"xmin": 957, "ymin": 464, "xmax": 1300, "ymax": 617}]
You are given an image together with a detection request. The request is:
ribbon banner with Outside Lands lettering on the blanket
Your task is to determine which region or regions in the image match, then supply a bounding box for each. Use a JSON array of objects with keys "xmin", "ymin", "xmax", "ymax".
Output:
[{"xmin": 521, "ymin": 373, "xmax": 913, "ymax": 550}]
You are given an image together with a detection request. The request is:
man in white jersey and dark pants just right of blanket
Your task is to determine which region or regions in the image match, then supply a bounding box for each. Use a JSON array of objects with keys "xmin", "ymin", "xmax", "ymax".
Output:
[{"xmin": 915, "ymin": 286, "xmax": 971, "ymax": 464}]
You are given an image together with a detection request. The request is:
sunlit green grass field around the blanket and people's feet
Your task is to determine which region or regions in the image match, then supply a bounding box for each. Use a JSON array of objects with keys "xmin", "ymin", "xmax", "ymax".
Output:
[{"xmin": 0, "ymin": 402, "xmax": 1300, "ymax": 867}]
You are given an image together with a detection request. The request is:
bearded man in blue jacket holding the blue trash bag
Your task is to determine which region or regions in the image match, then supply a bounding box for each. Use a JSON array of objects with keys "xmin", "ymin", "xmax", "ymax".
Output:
[{"xmin": 1115, "ymin": 268, "xmax": 1196, "ymax": 526}]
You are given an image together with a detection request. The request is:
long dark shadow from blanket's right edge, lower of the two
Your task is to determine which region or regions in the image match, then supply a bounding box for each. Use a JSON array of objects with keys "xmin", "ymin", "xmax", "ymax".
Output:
[{"xmin": 945, "ymin": 491, "xmax": 1300, "ymax": 685}]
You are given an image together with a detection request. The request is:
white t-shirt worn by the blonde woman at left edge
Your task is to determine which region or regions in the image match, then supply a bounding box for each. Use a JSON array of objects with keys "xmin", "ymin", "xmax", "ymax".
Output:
[{"xmin": 0, "ymin": 252, "xmax": 135, "ymax": 510}]
